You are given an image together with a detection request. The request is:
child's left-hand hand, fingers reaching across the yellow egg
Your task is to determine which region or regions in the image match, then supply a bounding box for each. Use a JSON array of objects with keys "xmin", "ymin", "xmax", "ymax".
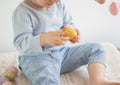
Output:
[{"xmin": 40, "ymin": 30, "xmax": 69, "ymax": 46}]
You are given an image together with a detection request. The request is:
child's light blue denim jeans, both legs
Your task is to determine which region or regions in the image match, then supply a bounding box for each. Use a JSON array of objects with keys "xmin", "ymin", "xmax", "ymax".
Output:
[{"xmin": 19, "ymin": 43, "xmax": 106, "ymax": 85}]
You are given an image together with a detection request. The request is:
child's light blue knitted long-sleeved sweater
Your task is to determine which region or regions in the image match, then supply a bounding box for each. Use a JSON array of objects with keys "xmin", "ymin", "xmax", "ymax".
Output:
[{"xmin": 12, "ymin": 0, "xmax": 73, "ymax": 55}]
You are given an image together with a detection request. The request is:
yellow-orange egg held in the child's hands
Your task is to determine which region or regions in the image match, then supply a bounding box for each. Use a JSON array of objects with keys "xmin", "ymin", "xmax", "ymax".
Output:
[{"xmin": 63, "ymin": 26, "xmax": 77, "ymax": 39}]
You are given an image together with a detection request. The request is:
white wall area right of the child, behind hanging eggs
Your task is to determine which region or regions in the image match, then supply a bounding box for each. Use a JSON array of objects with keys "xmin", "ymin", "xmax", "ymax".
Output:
[{"xmin": 67, "ymin": 0, "xmax": 120, "ymax": 47}]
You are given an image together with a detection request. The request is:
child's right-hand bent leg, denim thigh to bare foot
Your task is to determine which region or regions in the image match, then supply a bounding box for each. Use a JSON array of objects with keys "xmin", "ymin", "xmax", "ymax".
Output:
[{"xmin": 61, "ymin": 43, "xmax": 120, "ymax": 85}]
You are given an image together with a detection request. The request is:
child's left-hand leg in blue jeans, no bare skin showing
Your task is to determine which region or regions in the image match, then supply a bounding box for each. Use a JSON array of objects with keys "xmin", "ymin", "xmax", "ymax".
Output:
[{"xmin": 19, "ymin": 53, "xmax": 61, "ymax": 85}]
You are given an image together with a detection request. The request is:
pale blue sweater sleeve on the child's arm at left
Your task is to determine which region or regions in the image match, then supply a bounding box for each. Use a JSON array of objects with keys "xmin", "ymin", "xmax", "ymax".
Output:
[{"xmin": 12, "ymin": 8, "xmax": 43, "ymax": 54}]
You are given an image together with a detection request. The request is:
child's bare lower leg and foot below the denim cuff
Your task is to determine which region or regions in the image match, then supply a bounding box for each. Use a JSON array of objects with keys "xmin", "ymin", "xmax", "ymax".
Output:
[{"xmin": 88, "ymin": 63, "xmax": 120, "ymax": 85}]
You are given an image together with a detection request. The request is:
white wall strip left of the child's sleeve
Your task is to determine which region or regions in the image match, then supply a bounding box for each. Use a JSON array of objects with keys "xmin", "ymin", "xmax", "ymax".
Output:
[{"xmin": 0, "ymin": 0, "xmax": 22, "ymax": 52}]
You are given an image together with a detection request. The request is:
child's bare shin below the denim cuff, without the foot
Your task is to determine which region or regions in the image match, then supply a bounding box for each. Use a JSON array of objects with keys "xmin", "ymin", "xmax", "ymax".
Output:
[{"xmin": 88, "ymin": 63, "xmax": 105, "ymax": 85}]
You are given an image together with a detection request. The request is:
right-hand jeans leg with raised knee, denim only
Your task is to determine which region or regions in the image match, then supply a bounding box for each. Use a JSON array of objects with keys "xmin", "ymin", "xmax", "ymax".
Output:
[{"xmin": 61, "ymin": 43, "xmax": 106, "ymax": 73}]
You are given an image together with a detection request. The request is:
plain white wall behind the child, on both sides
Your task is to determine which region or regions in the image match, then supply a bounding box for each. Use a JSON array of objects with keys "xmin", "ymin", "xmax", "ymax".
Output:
[{"xmin": 0, "ymin": 0, "xmax": 120, "ymax": 52}]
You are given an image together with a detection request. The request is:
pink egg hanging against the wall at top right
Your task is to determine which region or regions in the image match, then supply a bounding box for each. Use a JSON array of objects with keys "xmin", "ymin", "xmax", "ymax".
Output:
[{"xmin": 109, "ymin": 2, "xmax": 119, "ymax": 16}]
